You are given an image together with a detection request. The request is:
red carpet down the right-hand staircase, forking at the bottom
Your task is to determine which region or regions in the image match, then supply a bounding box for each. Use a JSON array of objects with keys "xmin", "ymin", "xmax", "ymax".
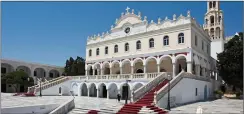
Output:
[{"xmin": 117, "ymin": 80, "xmax": 168, "ymax": 114}]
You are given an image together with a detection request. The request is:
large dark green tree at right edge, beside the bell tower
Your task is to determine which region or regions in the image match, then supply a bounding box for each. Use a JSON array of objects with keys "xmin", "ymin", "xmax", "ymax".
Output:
[{"xmin": 217, "ymin": 33, "xmax": 243, "ymax": 90}]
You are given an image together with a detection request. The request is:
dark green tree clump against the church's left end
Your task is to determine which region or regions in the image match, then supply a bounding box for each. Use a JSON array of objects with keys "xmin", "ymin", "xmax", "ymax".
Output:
[{"xmin": 64, "ymin": 56, "xmax": 85, "ymax": 76}]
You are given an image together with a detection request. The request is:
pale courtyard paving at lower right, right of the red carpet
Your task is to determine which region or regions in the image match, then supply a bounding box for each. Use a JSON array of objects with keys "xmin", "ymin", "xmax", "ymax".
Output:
[{"xmin": 170, "ymin": 99, "xmax": 243, "ymax": 114}]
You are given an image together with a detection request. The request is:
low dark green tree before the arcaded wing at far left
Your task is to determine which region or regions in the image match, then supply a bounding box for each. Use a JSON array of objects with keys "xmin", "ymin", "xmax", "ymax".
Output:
[{"xmin": 1, "ymin": 71, "xmax": 34, "ymax": 92}]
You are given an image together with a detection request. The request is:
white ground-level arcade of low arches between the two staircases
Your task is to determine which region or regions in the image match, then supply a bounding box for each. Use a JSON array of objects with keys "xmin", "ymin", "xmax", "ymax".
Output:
[{"xmin": 76, "ymin": 82, "xmax": 145, "ymax": 99}]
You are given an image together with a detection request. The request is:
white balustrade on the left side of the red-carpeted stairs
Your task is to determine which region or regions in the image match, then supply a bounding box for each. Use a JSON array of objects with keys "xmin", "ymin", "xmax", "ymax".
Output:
[{"xmin": 132, "ymin": 72, "xmax": 168, "ymax": 101}]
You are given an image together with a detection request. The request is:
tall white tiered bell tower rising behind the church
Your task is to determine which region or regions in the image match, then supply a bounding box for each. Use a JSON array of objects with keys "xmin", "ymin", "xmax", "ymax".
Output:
[{"xmin": 203, "ymin": 0, "xmax": 225, "ymax": 60}]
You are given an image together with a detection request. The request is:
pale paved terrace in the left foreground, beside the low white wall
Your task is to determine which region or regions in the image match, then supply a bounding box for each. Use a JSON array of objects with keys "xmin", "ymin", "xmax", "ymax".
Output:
[{"xmin": 1, "ymin": 93, "xmax": 73, "ymax": 108}]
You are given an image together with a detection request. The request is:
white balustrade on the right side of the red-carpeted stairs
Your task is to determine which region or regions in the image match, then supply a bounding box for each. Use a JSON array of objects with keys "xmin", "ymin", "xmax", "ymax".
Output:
[{"xmin": 154, "ymin": 70, "xmax": 186, "ymax": 104}]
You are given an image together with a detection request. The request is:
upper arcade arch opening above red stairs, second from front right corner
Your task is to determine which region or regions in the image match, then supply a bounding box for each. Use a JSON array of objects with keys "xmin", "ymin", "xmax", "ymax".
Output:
[{"xmin": 159, "ymin": 56, "xmax": 173, "ymax": 72}]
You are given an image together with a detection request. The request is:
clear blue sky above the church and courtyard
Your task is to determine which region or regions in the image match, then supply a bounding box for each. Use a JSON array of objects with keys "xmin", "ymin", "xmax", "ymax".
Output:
[{"xmin": 2, "ymin": 2, "xmax": 243, "ymax": 66}]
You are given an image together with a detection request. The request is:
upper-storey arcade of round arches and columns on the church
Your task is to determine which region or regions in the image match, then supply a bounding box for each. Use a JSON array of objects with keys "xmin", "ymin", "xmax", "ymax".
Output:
[{"xmin": 86, "ymin": 54, "xmax": 214, "ymax": 76}]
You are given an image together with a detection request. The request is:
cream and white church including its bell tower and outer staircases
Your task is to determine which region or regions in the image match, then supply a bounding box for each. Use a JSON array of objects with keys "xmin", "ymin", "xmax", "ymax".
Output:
[{"xmin": 26, "ymin": 1, "xmax": 225, "ymax": 112}]
